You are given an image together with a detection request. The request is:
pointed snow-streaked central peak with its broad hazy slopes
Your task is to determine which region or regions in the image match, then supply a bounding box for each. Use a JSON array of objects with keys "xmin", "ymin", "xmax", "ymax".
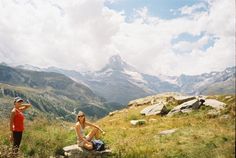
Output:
[{"xmin": 40, "ymin": 55, "xmax": 181, "ymax": 105}]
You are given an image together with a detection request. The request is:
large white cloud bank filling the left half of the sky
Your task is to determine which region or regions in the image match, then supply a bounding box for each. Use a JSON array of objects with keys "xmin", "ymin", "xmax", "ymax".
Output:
[{"xmin": 0, "ymin": 0, "xmax": 123, "ymax": 70}]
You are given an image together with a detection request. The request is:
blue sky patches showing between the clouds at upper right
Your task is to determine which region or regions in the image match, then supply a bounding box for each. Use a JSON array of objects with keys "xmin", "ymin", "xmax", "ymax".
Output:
[{"xmin": 105, "ymin": 0, "xmax": 215, "ymax": 51}]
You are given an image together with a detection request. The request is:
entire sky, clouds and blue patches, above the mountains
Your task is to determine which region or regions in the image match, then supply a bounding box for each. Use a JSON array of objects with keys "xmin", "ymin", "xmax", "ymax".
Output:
[{"xmin": 0, "ymin": 0, "xmax": 235, "ymax": 76}]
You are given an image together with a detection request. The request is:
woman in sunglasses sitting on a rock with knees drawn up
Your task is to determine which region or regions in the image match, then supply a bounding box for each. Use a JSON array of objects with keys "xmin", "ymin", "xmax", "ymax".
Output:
[{"xmin": 75, "ymin": 111, "xmax": 105, "ymax": 150}]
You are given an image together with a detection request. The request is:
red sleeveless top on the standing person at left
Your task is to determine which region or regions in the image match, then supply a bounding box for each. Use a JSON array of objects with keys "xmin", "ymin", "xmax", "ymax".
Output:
[{"xmin": 13, "ymin": 109, "xmax": 25, "ymax": 132}]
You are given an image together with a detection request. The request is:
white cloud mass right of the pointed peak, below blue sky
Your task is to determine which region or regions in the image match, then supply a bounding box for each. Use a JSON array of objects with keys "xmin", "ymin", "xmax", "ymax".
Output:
[{"xmin": 111, "ymin": 0, "xmax": 235, "ymax": 75}]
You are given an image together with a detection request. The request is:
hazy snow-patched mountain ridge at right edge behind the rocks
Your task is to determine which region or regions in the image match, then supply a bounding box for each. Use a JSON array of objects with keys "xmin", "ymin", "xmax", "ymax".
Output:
[{"xmin": 177, "ymin": 67, "xmax": 236, "ymax": 95}]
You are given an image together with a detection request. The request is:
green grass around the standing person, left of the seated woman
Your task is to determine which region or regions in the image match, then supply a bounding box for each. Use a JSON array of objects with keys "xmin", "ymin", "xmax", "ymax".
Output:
[{"xmin": 0, "ymin": 118, "xmax": 76, "ymax": 158}]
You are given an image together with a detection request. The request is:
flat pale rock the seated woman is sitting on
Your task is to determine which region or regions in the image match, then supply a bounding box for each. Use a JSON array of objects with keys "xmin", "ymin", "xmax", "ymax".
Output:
[{"xmin": 63, "ymin": 144, "xmax": 112, "ymax": 158}]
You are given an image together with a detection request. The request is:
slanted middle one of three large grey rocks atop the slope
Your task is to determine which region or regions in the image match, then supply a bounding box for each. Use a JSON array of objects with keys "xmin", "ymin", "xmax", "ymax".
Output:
[{"xmin": 167, "ymin": 99, "xmax": 201, "ymax": 116}]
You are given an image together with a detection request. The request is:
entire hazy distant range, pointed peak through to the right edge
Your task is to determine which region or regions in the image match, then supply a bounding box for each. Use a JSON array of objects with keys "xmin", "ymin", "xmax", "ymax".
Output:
[{"xmin": 6, "ymin": 55, "xmax": 236, "ymax": 104}]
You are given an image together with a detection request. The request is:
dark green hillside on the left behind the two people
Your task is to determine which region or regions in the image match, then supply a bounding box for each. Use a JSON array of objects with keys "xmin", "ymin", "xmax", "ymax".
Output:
[{"xmin": 0, "ymin": 65, "xmax": 120, "ymax": 121}]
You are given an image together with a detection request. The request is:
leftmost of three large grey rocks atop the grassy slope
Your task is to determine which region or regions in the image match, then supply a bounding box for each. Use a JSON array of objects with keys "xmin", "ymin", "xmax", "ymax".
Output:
[{"xmin": 140, "ymin": 103, "xmax": 167, "ymax": 116}]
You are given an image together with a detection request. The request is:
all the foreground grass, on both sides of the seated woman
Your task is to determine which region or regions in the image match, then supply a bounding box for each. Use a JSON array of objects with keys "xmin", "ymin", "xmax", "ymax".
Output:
[{"xmin": 0, "ymin": 96, "xmax": 235, "ymax": 158}]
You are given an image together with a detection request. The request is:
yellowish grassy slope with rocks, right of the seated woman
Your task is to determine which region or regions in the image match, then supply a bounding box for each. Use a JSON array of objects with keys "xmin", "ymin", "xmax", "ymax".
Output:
[{"xmin": 99, "ymin": 96, "xmax": 235, "ymax": 158}]
